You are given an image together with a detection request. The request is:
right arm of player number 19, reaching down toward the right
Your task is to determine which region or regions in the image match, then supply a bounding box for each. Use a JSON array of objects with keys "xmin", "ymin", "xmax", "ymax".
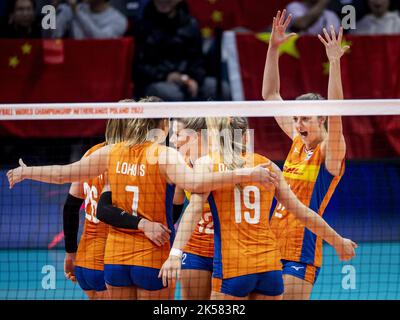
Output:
[{"xmin": 274, "ymin": 165, "xmax": 357, "ymax": 260}]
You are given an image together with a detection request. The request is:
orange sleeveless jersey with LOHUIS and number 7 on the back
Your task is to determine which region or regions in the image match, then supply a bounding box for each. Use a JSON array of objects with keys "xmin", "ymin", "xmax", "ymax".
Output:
[{"xmin": 105, "ymin": 143, "xmax": 175, "ymax": 269}]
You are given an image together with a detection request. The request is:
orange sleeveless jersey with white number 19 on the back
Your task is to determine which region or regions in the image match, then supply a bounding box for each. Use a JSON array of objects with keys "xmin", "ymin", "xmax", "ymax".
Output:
[{"xmin": 209, "ymin": 154, "xmax": 282, "ymax": 279}]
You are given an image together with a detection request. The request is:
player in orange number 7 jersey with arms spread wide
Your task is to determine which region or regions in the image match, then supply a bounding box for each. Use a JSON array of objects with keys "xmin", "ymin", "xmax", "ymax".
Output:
[{"xmin": 7, "ymin": 115, "xmax": 276, "ymax": 299}]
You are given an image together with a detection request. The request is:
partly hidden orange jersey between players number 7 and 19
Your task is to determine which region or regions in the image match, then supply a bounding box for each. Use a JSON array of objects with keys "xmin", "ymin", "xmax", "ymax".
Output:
[{"xmin": 183, "ymin": 191, "xmax": 214, "ymax": 258}]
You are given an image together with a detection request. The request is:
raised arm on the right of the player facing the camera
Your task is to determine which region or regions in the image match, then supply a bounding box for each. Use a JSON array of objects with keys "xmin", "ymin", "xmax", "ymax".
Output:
[{"xmin": 318, "ymin": 26, "xmax": 350, "ymax": 176}]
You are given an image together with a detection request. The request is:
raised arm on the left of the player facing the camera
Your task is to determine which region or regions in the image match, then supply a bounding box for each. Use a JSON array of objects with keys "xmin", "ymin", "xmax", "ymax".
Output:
[{"xmin": 262, "ymin": 10, "xmax": 296, "ymax": 139}]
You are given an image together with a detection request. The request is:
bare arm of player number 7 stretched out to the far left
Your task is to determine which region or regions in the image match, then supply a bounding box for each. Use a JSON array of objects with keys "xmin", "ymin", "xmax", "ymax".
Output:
[{"xmin": 7, "ymin": 146, "xmax": 111, "ymax": 189}]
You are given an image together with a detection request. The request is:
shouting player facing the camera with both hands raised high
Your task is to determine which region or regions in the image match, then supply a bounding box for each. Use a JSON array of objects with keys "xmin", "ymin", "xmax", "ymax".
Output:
[{"xmin": 262, "ymin": 10, "xmax": 349, "ymax": 299}]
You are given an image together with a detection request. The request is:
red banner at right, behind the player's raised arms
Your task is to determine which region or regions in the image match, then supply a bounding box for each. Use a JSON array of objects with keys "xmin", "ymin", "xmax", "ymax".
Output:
[{"xmin": 236, "ymin": 34, "xmax": 400, "ymax": 159}]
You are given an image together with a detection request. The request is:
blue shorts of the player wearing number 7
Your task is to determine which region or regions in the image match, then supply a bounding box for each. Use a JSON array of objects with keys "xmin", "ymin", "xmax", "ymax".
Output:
[{"xmin": 104, "ymin": 264, "xmax": 164, "ymax": 291}]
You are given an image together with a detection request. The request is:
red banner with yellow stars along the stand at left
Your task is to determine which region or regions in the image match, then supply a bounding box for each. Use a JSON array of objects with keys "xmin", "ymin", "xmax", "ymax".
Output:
[{"xmin": 0, "ymin": 38, "xmax": 133, "ymax": 137}]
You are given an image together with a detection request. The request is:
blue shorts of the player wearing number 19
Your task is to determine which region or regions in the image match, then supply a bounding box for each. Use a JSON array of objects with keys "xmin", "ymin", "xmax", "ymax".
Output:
[{"xmin": 212, "ymin": 270, "xmax": 283, "ymax": 298}]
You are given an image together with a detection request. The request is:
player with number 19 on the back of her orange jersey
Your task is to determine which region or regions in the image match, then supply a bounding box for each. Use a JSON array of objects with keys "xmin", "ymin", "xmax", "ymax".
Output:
[{"xmin": 159, "ymin": 118, "xmax": 356, "ymax": 300}]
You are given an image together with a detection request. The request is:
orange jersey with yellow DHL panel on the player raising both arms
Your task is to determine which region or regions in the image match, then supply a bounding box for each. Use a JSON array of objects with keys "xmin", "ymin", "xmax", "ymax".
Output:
[{"xmin": 271, "ymin": 136, "xmax": 344, "ymax": 267}]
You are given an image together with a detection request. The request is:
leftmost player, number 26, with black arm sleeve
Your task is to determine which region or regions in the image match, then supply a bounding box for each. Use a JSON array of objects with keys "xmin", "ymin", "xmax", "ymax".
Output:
[{"xmin": 63, "ymin": 119, "xmax": 127, "ymax": 300}]
